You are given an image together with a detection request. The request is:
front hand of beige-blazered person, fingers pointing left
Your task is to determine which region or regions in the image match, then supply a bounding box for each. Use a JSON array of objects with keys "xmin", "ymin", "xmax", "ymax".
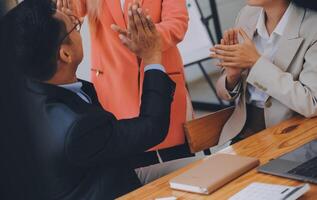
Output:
[{"xmin": 211, "ymin": 29, "xmax": 261, "ymax": 69}]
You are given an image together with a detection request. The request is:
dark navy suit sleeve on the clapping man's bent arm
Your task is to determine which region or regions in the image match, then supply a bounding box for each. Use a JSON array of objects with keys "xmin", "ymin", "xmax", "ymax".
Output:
[{"xmin": 66, "ymin": 70, "xmax": 175, "ymax": 165}]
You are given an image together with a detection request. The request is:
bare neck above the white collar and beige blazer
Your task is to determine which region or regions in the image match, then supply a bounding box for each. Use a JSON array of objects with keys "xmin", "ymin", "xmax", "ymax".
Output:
[{"xmin": 264, "ymin": 1, "xmax": 289, "ymax": 35}]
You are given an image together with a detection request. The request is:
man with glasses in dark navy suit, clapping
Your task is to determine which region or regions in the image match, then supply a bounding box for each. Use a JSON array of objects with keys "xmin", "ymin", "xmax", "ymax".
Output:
[{"xmin": 2, "ymin": 1, "xmax": 175, "ymax": 200}]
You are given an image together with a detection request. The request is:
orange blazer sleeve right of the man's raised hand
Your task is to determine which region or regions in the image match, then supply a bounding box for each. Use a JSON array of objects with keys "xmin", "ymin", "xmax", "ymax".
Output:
[{"xmin": 156, "ymin": 0, "xmax": 189, "ymax": 51}]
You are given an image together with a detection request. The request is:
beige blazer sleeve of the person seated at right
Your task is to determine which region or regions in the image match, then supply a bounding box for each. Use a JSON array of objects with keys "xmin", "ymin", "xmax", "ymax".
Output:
[{"xmin": 247, "ymin": 41, "xmax": 317, "ymax": 117}]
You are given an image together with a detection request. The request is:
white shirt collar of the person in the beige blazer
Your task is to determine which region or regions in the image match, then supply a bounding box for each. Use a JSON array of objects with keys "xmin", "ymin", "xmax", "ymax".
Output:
[{"xmin": 256, "ymin": 3, "xmax": 294, "ymax": 40}]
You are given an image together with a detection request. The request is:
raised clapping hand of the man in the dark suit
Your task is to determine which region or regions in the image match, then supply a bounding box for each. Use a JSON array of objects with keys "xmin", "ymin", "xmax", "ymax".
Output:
[{"xmin": 111, "ymin": 2, "xmax": 162, "ymax": 65}]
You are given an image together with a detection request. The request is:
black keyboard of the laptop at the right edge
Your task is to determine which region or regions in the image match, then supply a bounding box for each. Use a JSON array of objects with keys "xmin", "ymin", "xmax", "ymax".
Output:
[{"xmin": 288, "ymin": 157, "xmax": 317, "ymax": 178}]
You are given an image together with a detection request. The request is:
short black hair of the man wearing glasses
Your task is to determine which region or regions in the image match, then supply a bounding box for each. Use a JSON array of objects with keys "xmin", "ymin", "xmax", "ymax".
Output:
[{"xmin": 6, "ymin": 0, "xmax": 66, "ymax": 81}]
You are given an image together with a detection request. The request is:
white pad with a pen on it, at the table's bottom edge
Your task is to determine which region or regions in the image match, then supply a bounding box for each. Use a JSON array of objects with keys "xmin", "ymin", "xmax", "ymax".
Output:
[{"xmin": 229, "ymin": 182, "xmax": 310, "ymax": 200}]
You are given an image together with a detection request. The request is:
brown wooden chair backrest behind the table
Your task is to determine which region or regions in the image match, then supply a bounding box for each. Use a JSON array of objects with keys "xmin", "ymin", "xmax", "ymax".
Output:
[{"xmin": 184, "ymin": 107, "xmax": 234, "ymax": 153}]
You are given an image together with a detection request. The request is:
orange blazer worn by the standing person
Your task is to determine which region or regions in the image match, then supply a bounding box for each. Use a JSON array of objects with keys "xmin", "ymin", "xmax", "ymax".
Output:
[{"xmin": 74, "ymin": 0, "xmax": 191, "ymax": 149}]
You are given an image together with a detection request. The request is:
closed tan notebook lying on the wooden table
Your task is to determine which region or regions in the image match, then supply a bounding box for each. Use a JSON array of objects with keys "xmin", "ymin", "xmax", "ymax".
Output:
[{"xmin": 170, "ymin": 154, "xmax": 260, "ymax": 194}]
